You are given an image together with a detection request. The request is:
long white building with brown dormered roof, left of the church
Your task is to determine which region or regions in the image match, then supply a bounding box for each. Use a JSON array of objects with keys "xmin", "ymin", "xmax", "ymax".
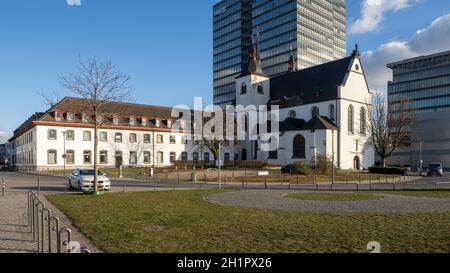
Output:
[{"xmin": 10, "ymin": 97, "xmax": 234, "ymax": 170}]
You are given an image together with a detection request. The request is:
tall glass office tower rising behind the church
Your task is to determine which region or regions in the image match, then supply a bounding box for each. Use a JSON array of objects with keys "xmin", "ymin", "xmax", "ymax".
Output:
[{"xmin": 213, "ymin": 0, "xmax": 346, "ymax": 105}]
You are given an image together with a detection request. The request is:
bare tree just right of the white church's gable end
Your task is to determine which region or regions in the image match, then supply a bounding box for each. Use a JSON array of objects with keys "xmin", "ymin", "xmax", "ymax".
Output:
[{"xmin": 367, "ymin": 93, "xmax": 415, "ymax": 167}]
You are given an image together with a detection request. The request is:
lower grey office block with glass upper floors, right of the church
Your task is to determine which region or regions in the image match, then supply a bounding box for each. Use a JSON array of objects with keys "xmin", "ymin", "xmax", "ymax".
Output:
[{"xmin": 388, "ymin": 51, "xmax": 450, "ymax": 168}]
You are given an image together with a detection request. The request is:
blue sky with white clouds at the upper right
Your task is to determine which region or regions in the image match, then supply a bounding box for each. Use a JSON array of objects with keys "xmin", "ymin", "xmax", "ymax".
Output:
[{"xmin": 0, "ymin": 0, "xmax": 450, "ymax": 141}]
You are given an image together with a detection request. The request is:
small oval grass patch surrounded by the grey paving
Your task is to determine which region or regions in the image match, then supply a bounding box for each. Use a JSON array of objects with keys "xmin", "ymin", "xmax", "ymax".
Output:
[{"xmin": 286, "ymin": 192, "xmax": 383, "ymax": 201}]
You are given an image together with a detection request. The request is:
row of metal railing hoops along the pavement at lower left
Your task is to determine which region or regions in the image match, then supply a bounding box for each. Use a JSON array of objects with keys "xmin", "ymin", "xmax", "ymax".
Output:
[{"xmin": 28, "ymin": 191, "xmax": 91, "ymax": 253}]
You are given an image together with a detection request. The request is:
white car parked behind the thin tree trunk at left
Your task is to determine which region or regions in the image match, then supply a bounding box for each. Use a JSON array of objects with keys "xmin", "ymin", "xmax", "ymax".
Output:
[{"xmin": 69, "ymin": 169, "xmax": 111, "ymax": 191}]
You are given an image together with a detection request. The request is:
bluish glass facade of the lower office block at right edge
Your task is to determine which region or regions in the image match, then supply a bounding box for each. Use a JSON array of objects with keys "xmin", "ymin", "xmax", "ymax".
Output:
[{"xmin": 388, "ymin": 52, "xmax": 450, "ymax": 113}]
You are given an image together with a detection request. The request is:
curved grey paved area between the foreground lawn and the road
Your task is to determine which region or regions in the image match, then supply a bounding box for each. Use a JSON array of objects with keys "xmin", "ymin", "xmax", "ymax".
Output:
[{"xmin": 208, "ymin": 190, "xmax": 450, "ymax": 214}]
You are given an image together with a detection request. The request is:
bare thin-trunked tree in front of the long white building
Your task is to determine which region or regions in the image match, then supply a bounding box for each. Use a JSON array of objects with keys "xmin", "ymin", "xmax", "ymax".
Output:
[{"xmin": 61, "ymin": 59, "xmax": 131, "ymax": 193}]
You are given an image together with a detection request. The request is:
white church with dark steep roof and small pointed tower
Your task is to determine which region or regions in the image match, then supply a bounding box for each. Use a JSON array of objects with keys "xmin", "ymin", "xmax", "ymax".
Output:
[{"xmin": 236, "ymin": 45, "xmax": 374, "ymax": 170}]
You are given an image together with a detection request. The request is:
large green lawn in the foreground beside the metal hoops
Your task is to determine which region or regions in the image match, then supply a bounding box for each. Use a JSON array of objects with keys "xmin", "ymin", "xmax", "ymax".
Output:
[{"xmin": 48, "ymin": 190, "xmax": 450, "ymax": 253}]
